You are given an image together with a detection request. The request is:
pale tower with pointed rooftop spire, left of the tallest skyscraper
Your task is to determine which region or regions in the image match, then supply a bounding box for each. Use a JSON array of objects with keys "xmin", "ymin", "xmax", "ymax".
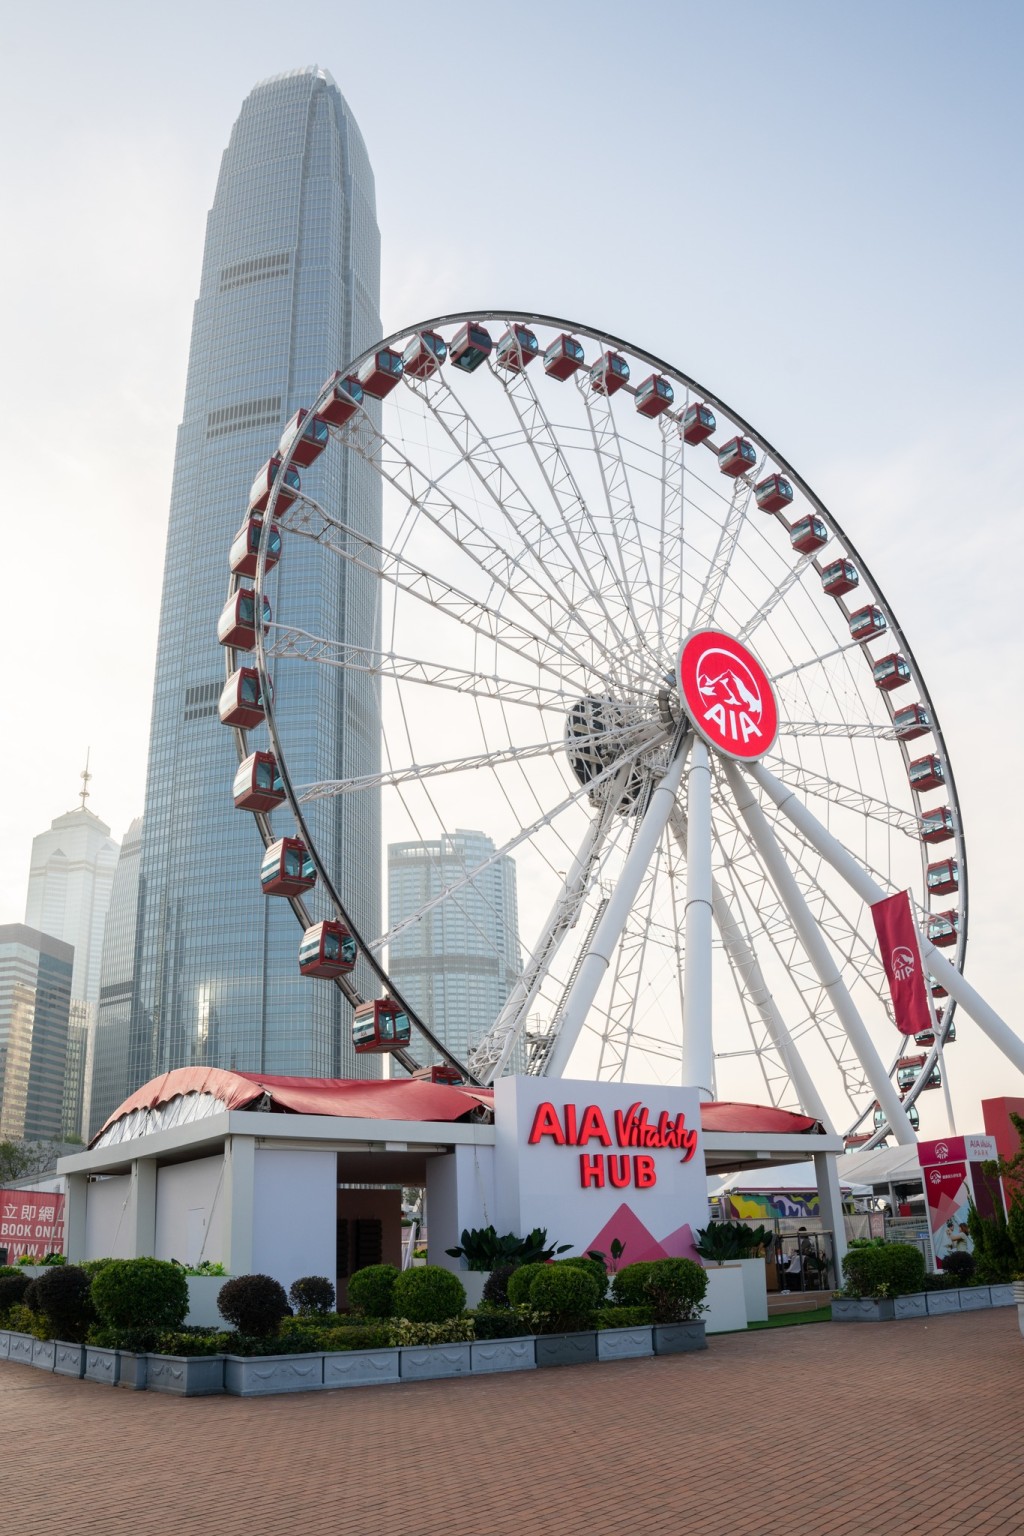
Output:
[{"xmin": 25, "ymin": 766, "xmax": 118, "ymax": 1137}]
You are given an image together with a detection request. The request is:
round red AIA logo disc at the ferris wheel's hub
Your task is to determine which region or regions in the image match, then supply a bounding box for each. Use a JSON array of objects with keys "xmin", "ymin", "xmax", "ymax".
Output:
[{"xmin": 679, "ymin": 630, "xmax": 778, "ymax": 762}]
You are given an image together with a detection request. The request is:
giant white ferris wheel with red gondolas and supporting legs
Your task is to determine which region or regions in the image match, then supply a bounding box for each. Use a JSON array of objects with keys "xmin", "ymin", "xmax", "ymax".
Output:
[{"xmin": 218, "ymin": 312, "xmax": 1024, "ymax": 1144}]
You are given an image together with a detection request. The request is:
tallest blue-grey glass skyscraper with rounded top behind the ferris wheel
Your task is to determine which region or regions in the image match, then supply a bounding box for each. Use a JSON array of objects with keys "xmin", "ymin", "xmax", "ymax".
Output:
[{"xmin": 92, "ymin": 68, "xmax": 381, "ymax": 1124}]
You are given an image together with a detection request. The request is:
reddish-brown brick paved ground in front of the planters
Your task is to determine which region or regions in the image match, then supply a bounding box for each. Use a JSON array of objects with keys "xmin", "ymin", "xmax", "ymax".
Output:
[{"xmin": 0, "ymin": 1307, "xmax": 1024, "ymax": 1536}]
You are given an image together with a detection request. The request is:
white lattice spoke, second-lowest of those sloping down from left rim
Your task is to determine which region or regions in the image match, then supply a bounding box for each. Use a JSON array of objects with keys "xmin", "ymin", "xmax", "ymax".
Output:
[{"xmin": 279, "ymin": 498, "xmax": 613, "ymax": 688}]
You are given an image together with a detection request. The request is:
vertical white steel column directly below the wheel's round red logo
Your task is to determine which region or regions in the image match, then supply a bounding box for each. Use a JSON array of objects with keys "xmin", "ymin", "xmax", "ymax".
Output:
[{"xmin": 682, "ymin": 734, "xmax": 715, "ymax": 1100}]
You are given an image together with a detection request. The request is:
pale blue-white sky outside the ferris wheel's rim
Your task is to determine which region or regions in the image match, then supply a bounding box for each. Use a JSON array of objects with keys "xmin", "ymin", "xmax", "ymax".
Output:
[{"xmin": 0, "ymin": 0, "xmax": 1024, "ymax": 1130}]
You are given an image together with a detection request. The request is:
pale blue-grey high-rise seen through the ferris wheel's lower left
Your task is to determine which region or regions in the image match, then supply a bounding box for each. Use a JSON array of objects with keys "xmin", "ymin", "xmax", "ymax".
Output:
[{"xmin": 387, "ymin": 831, "xmax": 520, "ymax": 1061}]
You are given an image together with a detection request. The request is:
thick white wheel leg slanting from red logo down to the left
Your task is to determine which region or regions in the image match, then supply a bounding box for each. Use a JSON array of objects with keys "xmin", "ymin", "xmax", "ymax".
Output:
[{"xmin": 545, "ymin": 736, "xmax": 689, "ymax": 1077}]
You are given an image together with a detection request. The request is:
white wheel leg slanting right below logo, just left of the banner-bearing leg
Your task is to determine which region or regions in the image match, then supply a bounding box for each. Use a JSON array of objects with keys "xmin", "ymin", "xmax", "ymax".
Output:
[{"xmin": 725, "ymin": 762, "xmax": 917, "ymax": 1146}]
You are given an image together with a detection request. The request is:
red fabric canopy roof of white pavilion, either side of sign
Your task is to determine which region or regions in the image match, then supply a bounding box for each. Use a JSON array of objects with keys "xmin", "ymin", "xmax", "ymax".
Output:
[{"xmin": 92, "ymin": 1066, "xmax": 818, "ymax": 1143}]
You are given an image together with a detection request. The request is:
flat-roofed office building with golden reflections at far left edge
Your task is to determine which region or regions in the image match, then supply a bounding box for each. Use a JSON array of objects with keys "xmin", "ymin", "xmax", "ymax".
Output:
[{"xmin": 0, "ymin": 923, "xmax": 75, "ymax": 1140}]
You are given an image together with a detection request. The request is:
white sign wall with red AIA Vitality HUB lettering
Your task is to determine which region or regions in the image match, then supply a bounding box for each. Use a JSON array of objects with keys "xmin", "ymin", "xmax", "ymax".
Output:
[{"xmin": 494, "ymin": 1077, "xmax": 708, "ymax": 1263}]
